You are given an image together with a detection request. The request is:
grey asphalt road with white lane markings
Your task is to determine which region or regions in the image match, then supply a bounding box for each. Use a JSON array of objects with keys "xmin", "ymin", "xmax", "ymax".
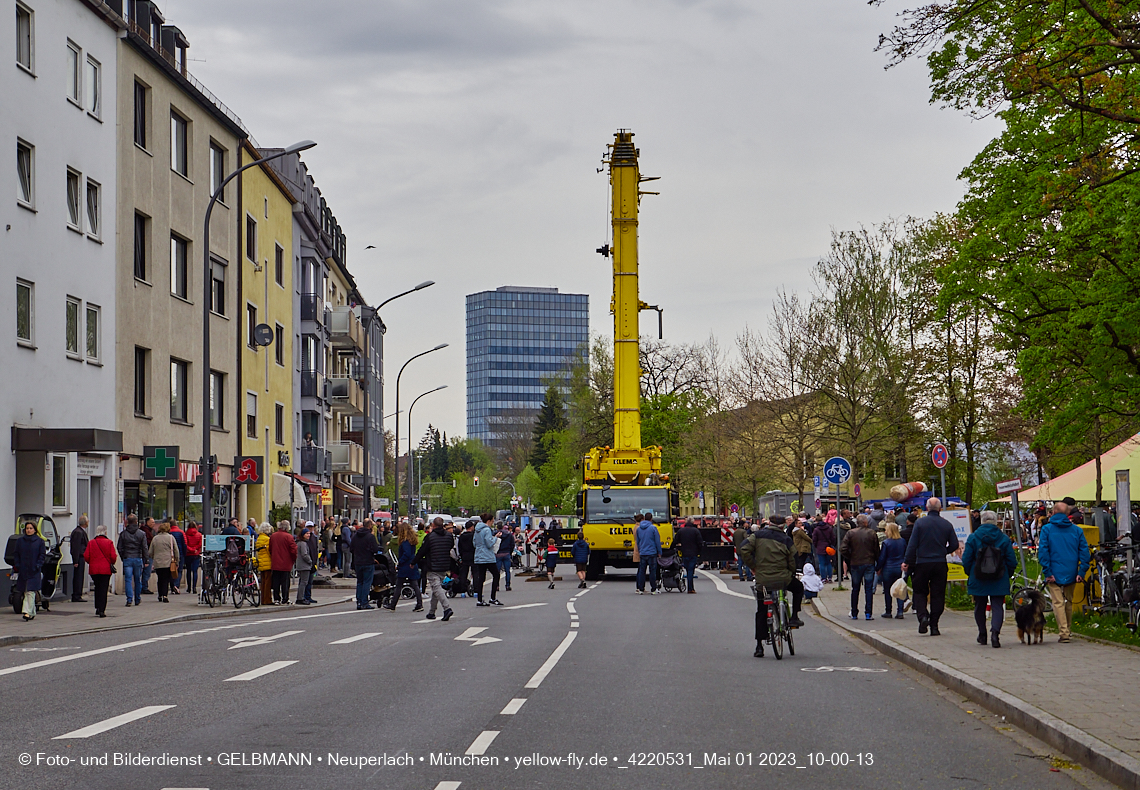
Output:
[{"xmin": 0, "ymin": 573, "xmax": 1103, "ymax": 790}]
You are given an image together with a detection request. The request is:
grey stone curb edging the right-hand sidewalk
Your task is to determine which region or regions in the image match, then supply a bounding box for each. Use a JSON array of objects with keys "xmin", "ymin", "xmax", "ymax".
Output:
[{"xmin": 812, "ymin": 598, "xmax": 1140, "ymax": 790}]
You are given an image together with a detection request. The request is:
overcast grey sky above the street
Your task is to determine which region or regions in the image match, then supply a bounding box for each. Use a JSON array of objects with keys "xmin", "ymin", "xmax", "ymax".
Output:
[{"xmin": 160, "ymin": 0, "xmax": 996, "ymax": 443}]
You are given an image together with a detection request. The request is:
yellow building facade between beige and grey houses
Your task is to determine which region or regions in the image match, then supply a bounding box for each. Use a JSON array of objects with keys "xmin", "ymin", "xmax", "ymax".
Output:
[{"xmin": 236, "ymin": 141, "xmax": 300, "ymax": 523}]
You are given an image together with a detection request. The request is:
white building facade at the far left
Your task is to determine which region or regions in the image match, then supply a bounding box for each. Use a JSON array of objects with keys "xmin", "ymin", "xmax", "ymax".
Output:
[{"xmin": 0, "ymin": 0, "xmax": 123, "ymax": 593}]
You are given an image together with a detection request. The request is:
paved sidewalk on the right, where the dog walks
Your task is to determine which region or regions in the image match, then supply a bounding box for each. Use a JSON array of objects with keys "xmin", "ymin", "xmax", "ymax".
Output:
[{"xmin": 814, "ymin": 583, "xmax": 1140, "ymax": 788}]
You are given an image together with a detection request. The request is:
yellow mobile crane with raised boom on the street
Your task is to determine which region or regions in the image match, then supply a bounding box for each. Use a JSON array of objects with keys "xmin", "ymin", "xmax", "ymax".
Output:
[{"xmin": 576, "ymin": 129, "xmax": 681, "ymax": 579}]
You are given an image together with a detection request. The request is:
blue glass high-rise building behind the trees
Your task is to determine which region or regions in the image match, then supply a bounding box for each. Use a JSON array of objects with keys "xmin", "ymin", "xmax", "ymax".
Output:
[{"xmin": 467, "ymin": 285, "xmax": 589, "ymax": 447}]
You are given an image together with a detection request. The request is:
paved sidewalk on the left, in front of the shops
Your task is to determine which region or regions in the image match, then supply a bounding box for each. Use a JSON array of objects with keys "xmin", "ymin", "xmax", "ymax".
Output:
[{"xmin": 0, "ymin": 578, "xmax": 356, "ymax": 645}]
